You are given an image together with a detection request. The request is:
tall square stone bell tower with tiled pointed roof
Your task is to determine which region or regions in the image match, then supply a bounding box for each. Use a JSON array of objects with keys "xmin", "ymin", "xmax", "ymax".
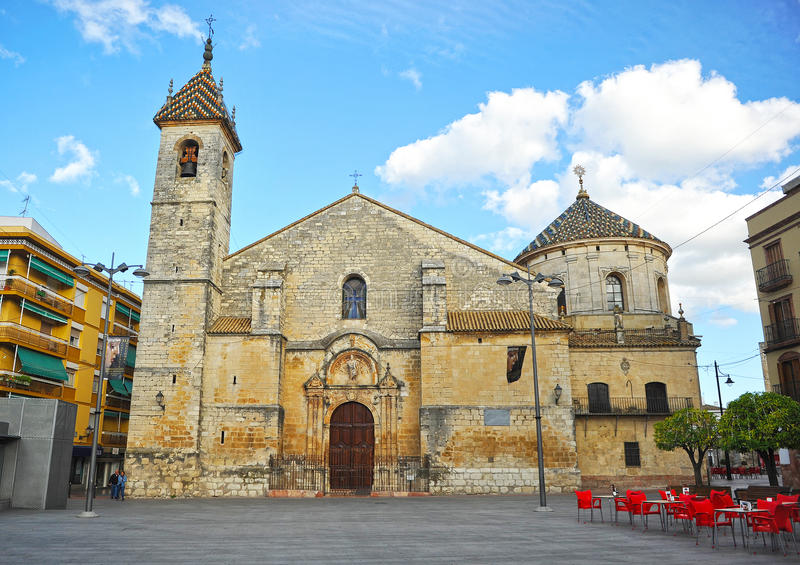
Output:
[{"xmin": 126, "ymin": 33, "xmax": 242, "ymax": 496}]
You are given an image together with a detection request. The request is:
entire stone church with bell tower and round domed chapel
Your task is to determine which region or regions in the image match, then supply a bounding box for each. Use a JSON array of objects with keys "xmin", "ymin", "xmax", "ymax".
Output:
[{"xmin": 125, "ymin": 39, "xmax": 700, "ymax": 497}]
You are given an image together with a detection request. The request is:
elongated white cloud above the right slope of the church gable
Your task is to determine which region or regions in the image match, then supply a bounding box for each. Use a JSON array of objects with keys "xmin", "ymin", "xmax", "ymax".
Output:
[{"xmin": 375, "ymin": 88, "xmax": 567, "ymax": 189}]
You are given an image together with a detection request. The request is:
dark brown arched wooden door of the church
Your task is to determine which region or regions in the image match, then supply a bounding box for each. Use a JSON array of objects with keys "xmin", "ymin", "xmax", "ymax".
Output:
[{"xmin": 329, "ymin": 402, "xmax": 375, "ymax": 490}]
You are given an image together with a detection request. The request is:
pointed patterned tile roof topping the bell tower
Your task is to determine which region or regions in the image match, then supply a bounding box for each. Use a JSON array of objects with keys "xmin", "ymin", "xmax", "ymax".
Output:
[{"xmin": 153, "ymin": 39, "xmax": 242, "ymax": 151}]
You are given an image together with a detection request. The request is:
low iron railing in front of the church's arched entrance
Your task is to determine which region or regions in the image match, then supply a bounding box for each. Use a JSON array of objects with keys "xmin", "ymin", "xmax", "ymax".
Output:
[{"xmin": 269, "ymin": 455, "xmax": 443, "ymax": 493}]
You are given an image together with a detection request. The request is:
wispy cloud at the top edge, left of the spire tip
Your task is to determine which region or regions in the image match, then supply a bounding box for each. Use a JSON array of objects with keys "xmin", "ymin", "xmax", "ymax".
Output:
[{"xmin": 51, "ymin": 0, "xmax": 203, "ymax": 53}]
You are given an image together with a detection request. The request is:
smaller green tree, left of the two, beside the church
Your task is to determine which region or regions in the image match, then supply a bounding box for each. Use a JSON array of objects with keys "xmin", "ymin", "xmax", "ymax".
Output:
[{"xmin": 653, "ymin": 408, "xmax": 719, "ymax": 485}]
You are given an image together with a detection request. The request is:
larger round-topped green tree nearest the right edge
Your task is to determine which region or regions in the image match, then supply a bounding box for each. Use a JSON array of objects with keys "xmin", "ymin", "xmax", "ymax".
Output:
[{"xmin": 719, "ymin": 392, "xmax": 800, "ymax": 486}]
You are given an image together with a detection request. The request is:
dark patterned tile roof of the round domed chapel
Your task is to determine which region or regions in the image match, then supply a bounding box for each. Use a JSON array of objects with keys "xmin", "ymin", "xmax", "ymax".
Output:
[{"xmin": 518, "ymin": 186, "xmax": 664, "ymax": 258}]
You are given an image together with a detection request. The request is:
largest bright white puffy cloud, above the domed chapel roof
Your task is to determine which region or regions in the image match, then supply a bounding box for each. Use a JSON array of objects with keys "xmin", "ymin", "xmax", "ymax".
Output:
[{"xmin": 573, "ymin": 60, "xmax": 800, "ymax": 182}]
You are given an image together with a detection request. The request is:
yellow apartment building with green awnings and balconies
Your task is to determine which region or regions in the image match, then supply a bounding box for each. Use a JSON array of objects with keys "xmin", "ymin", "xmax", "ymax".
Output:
[{"xmin": 0, "ymin": 217, "xmax": 141, "ymax": 486}]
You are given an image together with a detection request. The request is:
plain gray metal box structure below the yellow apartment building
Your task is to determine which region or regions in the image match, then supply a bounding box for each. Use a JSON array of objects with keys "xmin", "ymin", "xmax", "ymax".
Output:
[{"xmin": 0, "ymin": 398, "xmax": 78, "ymax": 510}]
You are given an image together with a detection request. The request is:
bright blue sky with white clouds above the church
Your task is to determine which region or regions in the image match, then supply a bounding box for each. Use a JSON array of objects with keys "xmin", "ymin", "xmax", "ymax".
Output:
[{"xmin": 0, "ymin": 0, "xmax": 800, "ymax": 403}]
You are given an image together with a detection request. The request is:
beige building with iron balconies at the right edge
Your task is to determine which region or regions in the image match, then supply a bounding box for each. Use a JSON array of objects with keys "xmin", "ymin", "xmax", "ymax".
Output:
[{"xmin": 745, "ymin": 177, "xmax": 800, "ymax": 488}]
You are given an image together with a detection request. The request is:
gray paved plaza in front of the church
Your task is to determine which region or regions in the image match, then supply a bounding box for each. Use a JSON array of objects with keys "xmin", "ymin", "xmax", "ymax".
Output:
[{"xmin": 0, "ymin": 495, "xmax": 800, "ymax": 565}]
